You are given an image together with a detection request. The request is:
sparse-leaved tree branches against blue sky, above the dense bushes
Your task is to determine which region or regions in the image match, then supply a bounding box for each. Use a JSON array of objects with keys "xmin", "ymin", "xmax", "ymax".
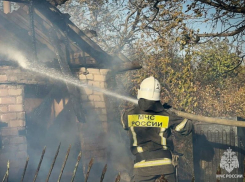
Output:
[{"xmin": 60, "ymin": 0, "xmax": 245, "ymax": 60}]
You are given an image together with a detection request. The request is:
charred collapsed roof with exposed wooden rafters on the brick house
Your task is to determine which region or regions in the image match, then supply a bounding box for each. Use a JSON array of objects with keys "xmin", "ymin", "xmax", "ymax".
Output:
[{"xmin": 0, "ymin": 0, "xmax": 140, "ymax": 70}]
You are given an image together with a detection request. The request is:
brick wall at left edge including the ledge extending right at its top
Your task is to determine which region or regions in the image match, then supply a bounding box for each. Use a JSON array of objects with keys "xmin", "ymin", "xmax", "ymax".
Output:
[{"xmin": 0, "ymin": 66, "xmax": 48, "ymax": 178}]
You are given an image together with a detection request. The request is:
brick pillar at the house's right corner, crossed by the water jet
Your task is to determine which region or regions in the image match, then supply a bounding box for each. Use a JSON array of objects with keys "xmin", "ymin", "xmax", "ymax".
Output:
[{"xmin": 78, "ymin": 68, "xmax": 109, "ymax": 163}]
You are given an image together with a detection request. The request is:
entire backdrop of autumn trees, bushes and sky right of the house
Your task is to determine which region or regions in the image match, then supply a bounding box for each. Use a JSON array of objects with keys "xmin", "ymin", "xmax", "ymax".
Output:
[{"xmin": 60, "ymin": 0, "xmax": 245, "ymax": 180}]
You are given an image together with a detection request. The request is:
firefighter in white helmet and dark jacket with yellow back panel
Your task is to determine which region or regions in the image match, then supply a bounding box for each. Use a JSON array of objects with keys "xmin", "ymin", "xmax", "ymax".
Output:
[{"xmin": 121, "ymin": 77, "xmax": 193, "ymax": 182}]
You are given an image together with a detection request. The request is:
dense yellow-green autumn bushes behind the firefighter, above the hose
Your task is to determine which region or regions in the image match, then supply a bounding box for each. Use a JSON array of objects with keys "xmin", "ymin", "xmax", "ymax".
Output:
[{"xmin": 118, "ymin": 39, "xmax": 245, "ymax": 117}]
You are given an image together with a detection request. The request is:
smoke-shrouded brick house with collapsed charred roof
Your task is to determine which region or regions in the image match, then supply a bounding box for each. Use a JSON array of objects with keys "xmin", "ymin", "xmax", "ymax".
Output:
[{"xmin": 0, "ymin": 0, "xmax": 139, "ymax": 181}]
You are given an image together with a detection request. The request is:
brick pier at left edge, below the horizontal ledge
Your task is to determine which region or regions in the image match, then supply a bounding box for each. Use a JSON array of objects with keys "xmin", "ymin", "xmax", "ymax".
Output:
[{"xmin": 0, "ymin": 84, "xmax": 27, "ymax": 178}]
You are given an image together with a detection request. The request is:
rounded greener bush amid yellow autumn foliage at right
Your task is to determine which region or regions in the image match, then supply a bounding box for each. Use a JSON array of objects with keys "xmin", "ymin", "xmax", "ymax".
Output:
[{"xmin": 192, "ymin": 39, "xmax": 241, "ymax": 86}]
